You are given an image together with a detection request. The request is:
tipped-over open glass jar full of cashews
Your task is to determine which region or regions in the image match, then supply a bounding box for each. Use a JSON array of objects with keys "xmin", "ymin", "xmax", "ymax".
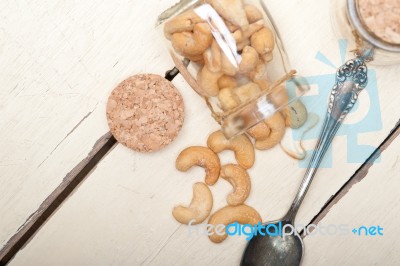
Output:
[{"xmin": 157, "ymin": 0, "xmax": 308, "ymax": 138}]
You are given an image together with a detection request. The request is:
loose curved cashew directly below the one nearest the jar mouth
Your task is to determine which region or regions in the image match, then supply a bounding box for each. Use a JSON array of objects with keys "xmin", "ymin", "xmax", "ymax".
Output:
[{"xmin": 221, "ymin": 164, "xmax": 251, "ymax": 206}]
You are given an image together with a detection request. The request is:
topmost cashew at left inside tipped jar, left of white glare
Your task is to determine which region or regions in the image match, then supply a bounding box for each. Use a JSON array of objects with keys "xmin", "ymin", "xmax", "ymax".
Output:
[{"xmin": 164, "ymin": 10, "xmax": 203, "ymax": 39}]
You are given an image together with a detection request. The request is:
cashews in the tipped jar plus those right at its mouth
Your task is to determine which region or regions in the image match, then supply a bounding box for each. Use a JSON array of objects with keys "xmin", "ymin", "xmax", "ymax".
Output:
[{"xmin": 164, "ymin": 0, "xmax": 307, "ymax": 153}]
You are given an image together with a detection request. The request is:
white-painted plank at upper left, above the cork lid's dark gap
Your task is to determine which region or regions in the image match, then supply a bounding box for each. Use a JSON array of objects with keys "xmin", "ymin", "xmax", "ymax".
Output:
[{"xmin": 0, "ymin": 0, "xmax": 176, "ymax": 252}]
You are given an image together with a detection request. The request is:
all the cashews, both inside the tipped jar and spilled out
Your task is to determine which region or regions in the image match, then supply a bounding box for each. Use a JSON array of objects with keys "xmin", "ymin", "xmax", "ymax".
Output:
[{"xmin": 168, "ymin": 0, "xmax": 307, "ymax": 243}]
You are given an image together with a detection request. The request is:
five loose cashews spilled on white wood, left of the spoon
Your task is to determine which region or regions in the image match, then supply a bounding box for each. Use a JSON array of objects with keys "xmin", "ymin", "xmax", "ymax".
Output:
[{"xmin": 172, "ymin": 131, "xmax": 261, "ymax": 243}]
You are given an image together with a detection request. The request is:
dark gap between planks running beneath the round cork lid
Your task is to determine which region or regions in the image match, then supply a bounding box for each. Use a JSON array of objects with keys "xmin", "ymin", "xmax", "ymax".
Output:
[{"xmin": 0, "ymin": 67, "xmax": 179, "ymax": 265}]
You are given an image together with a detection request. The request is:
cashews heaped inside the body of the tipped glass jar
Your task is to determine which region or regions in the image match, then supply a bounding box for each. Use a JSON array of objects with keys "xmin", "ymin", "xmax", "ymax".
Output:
[{"xmin": 164, "ymin": 0, "xmax": 275, "ymax": 101}]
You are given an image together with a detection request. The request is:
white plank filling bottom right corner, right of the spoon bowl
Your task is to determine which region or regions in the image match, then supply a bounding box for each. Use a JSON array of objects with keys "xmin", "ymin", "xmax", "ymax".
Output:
[{"xmin": 303, "ymin": 128, "xmax": 400, "ymax": 265}]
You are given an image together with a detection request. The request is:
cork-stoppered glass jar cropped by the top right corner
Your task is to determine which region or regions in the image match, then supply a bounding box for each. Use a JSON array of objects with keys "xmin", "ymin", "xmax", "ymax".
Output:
[{"xmin": 331, "ymin": 0, "xmax": 400, "ymax": 65}]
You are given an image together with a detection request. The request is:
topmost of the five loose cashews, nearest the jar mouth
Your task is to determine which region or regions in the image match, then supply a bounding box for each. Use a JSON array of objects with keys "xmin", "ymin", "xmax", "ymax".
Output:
[{"xmin": 207, "ymin": 130, "xmax": 255, "ymax": 169}]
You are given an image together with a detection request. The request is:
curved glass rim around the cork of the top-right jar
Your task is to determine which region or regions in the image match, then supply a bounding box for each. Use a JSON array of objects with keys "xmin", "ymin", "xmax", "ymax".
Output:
[{"xmin": 347, "ymin": 0, "xmax": 400, "ymax": 53}]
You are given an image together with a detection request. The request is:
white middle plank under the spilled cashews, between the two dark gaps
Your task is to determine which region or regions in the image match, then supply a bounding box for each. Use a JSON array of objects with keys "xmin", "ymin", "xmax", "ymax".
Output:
[{"xmin": 3, "ymin": 0, "xmax": 400, "ymax": 265}]
